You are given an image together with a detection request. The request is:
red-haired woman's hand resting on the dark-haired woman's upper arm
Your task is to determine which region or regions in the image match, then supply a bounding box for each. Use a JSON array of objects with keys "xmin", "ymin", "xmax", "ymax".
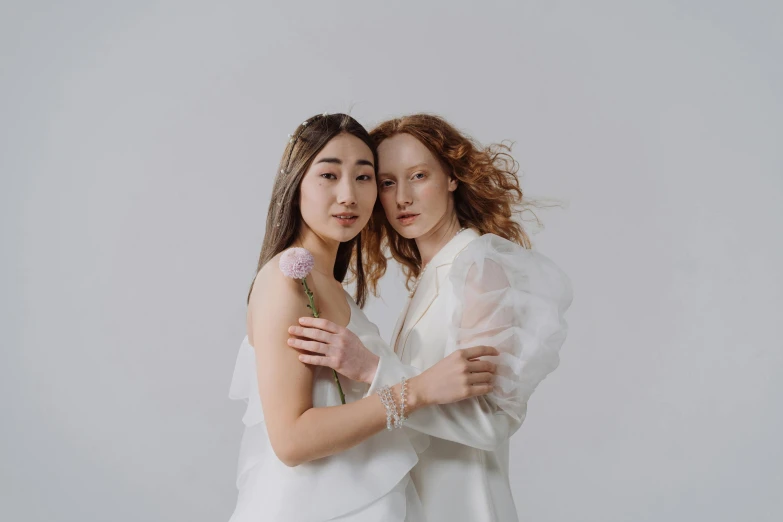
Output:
[{"xmin": 288, "ymin": 317, "xmax": 379, "ymax": 384}]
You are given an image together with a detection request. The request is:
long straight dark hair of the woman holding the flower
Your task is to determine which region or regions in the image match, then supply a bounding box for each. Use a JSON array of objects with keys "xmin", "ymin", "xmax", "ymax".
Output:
[{"xmin": 247, "ymin": 110, "xmax": 378, "ymax": 306}]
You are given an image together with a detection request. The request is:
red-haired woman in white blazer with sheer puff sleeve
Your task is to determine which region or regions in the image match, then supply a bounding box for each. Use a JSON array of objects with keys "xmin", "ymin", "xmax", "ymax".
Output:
[{"xmin": 291, "ymin": 114, "xmax": 572, "ymax": 522}]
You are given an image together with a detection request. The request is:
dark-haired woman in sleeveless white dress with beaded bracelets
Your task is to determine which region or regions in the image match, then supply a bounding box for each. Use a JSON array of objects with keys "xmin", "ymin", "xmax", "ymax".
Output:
[{"xmin": 230, "ymin": 114, "xmax": 498, "ymax": 522}]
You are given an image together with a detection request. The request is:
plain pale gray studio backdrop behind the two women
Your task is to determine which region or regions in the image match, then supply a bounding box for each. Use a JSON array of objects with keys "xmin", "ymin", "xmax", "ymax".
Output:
[{"xmin": 0, "ymin": 0, "xmax": 783, "ymax": 522}]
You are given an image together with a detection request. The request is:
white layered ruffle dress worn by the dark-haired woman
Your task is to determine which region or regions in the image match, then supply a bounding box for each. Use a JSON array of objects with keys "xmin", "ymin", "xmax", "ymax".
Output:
[{"xmin": 229, "ymin": 293, "xmax": 426, "ymax": 522}]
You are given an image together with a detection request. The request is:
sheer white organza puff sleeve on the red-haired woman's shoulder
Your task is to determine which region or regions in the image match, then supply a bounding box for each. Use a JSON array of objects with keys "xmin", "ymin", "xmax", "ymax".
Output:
[{"xmin": 446, "ymin": 234, "xmax": 572, "ymax": 423}]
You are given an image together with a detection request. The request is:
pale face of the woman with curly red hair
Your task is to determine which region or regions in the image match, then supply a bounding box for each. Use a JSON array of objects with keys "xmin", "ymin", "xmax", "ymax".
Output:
[{"xmin": 378, "ymin": 134, "xmax": 457, "ymax": 239}]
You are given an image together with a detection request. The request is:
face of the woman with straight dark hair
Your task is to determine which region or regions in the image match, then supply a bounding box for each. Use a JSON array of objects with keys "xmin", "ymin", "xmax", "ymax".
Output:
[{"xmin": 299, "ymin": 133, "xmax": 378, "ymax": 242}]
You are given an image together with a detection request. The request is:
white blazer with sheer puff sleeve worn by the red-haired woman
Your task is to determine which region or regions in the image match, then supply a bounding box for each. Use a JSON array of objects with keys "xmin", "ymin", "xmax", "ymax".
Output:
[{"xmin": 367, "ymin": 229, "xmax": 572, "ymax": 522}]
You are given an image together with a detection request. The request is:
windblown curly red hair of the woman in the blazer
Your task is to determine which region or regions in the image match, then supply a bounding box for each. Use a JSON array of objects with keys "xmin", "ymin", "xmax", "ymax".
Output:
[{"xmin": 362, "ymin": 114, "xmax": 530, "ymax": 293}]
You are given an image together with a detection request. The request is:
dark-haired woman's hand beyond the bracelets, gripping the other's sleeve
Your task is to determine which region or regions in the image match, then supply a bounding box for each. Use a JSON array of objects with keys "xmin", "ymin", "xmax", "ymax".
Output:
[{"xmin": 409, "ymin": 346, "xmax": 500, "ymax": 409}]
